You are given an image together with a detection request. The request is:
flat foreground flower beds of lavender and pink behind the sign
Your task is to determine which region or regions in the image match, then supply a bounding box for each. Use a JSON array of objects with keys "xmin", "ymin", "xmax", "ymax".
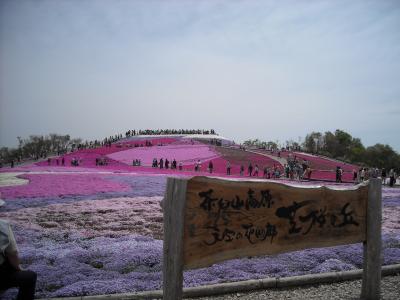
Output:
[{"xmin": 0, "ymin": 168, "xmax": 400, "ymax": 299}]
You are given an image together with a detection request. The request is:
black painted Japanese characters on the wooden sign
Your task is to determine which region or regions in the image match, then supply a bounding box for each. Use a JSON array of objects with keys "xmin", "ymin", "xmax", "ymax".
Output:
[{"xmin": 196, "ymin": 188, "xmax": 359, "ymax": 246}]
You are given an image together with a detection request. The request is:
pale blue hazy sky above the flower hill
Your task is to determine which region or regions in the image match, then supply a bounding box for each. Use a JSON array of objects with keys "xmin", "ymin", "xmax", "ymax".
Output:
[{"xmin": 0, "ymin": 0, "xmax": 400, "ymax": 152}]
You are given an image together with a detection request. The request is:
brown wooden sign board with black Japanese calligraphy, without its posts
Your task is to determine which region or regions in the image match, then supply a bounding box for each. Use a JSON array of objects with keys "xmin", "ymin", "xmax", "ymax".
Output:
[{"xmin": 183, "ymin": 177, "xmax": 368, "ymax": 268}]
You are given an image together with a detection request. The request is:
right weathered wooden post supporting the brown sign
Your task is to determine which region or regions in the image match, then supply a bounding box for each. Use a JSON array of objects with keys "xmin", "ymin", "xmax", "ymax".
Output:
[{"xmin": 361, "ymin": 178, "xmax": 382, "ymax": 300}]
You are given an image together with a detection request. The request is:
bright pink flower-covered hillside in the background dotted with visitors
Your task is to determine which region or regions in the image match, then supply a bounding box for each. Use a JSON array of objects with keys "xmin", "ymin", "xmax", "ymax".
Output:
[{"xmin": 5, "ymin": 137, "xmax": 357, "ymax": 182}]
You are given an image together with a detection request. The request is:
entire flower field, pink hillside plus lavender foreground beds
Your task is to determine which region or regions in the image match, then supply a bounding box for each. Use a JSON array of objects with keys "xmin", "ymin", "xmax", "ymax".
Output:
[{"xmin": 0, "ymin": 137, "xmax": 400, "ymax": 299}]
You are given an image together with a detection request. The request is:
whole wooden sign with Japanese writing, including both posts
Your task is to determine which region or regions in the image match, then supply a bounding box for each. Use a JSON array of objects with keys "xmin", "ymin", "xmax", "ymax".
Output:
[{"xmin": 163, "ymin": 177, "xmax": 382, "ymax": 300}]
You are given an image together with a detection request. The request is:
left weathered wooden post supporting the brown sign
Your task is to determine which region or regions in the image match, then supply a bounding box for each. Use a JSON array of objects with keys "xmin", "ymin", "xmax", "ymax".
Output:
[{"xmin": 163, "ymin": 178, "xmax": 187, "ymax": 300}]
